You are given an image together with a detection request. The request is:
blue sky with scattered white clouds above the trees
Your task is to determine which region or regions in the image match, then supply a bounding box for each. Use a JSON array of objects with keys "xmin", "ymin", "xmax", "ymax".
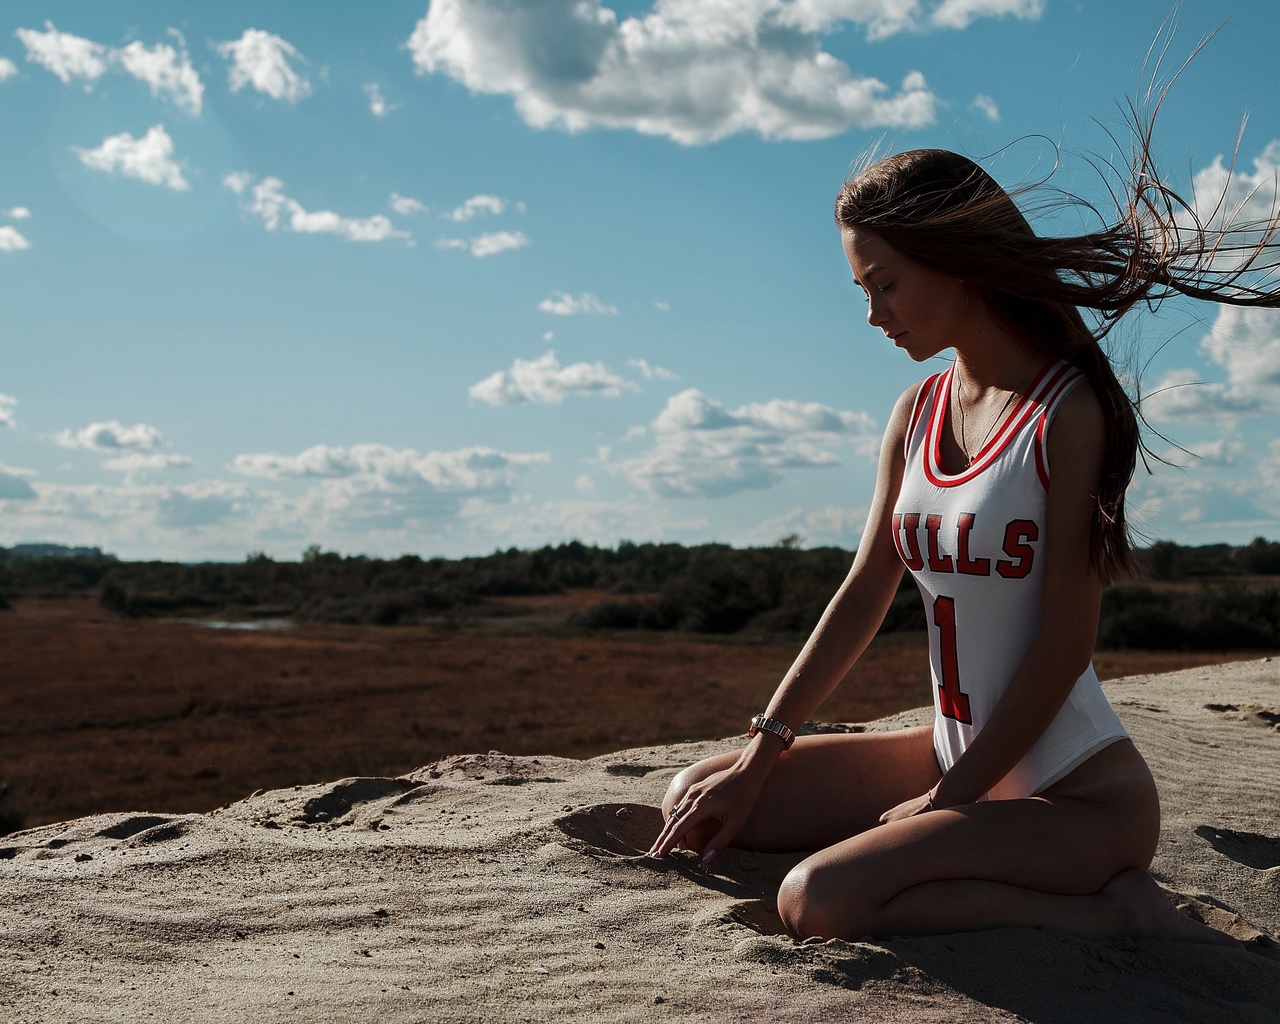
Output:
[{"xmin": 0, "ymin": 0, "xmax": 1280, "ymax": 561}]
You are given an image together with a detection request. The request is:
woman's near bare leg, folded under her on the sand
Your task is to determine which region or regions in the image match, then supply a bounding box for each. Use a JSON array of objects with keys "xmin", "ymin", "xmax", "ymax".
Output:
[{"xmin": 778, "ymin": 741, "xmax": 1234, "ymax": 945}]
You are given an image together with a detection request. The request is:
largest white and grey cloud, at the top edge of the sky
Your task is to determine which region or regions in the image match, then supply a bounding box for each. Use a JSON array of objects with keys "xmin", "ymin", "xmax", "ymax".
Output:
[{"xmin": 408, "ymin": 0, "xmax": 1043, "ymax": 145}]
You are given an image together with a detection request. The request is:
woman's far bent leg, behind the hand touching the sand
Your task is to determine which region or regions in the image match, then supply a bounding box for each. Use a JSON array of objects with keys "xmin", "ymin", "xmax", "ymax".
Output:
[{"xmin": 663, "ymin": 727, "xmax": 941, "ymax": 851}]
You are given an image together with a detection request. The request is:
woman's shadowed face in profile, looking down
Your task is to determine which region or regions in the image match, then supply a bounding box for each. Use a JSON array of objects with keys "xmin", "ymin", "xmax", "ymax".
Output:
[{"xmin": 841, "ymin": 228, "xmax": 980, "ymax": 362}]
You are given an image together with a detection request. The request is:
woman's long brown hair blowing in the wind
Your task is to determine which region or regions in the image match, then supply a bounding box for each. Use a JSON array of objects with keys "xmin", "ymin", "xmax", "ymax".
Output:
[{"xmin": 836, "ymin": 136, "xmax": 1280, "ymax": 581}]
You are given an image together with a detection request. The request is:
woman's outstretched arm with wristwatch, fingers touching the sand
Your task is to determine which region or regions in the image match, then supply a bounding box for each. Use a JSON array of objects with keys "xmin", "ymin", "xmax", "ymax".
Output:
[{"xmin": 650, "ymin": 385, "xmax": 919, "ymax": 859}]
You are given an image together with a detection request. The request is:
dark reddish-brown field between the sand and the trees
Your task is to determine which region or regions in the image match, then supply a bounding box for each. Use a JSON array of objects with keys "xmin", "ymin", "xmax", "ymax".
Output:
[{"xmin": 0, "ymin": 593, "xmax": 1256, "ymax": 828}]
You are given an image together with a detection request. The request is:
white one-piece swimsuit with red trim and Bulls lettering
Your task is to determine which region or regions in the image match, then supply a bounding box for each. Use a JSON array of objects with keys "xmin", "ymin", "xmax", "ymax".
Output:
[{"xmin": 893, "ymin": 362, "xmax": 1128, "ymax": 800}]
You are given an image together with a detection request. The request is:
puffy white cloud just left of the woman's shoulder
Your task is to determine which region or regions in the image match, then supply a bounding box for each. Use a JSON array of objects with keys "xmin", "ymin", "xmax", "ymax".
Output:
[{"xmin": 620, "ymin": 388, "xmax": 879, "ymax": 498}]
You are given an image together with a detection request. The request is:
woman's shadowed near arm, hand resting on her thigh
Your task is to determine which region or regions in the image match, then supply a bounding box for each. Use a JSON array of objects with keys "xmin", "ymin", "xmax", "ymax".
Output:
[{"xmin": 916, "ymin": 387, "xmax": 1106, "ymax": 808}]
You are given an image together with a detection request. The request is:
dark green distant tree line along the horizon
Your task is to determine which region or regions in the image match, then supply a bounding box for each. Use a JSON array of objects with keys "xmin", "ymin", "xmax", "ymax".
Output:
[{"xmin": 0, "ymin": 536, "xmax": 1280, "ymax": 650}]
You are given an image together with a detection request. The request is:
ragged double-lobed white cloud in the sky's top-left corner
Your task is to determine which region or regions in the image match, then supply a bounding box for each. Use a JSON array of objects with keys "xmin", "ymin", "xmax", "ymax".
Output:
[{"xmin": 14, "ymin": 22, "xmax": 205, "ymax": 116}]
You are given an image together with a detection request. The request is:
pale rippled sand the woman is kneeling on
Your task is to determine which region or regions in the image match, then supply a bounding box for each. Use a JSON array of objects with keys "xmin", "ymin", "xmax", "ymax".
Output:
[{"xmin": 0, "ymin": 662, "xmax": 1280, "ymax": 1024}]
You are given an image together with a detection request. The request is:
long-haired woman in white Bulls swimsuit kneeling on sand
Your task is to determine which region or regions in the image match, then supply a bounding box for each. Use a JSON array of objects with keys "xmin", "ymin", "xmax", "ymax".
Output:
[{"xmin": 650, "ymin": 146, "xmax": 1280, "ymax": 945}]
